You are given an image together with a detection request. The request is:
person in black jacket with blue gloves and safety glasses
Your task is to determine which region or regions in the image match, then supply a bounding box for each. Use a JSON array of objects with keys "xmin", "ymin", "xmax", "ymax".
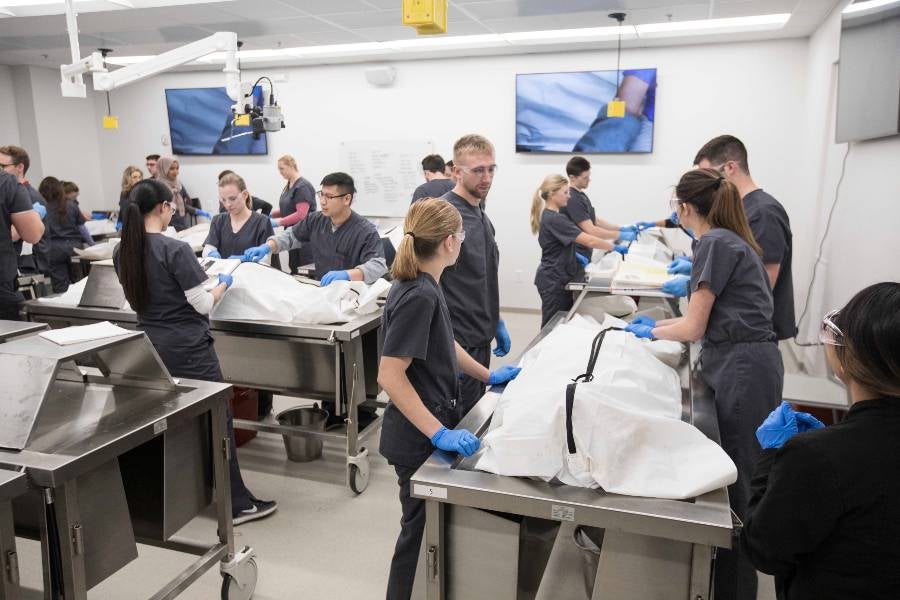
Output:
[{"xmin": 741, "ymin": 282, "xmax": 900, "ymax": 600}]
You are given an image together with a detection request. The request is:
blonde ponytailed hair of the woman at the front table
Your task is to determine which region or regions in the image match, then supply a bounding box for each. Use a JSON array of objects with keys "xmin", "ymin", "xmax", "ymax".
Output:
[{"xmin": 391, "ymin": 198, "xmax": 462, "ymax": 281}]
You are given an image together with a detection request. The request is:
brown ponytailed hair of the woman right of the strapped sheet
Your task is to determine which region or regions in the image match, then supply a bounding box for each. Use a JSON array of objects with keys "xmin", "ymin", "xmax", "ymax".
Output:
[{"xmin": 675, "ymin": 169, "xmax": 762, "ymax": 256}]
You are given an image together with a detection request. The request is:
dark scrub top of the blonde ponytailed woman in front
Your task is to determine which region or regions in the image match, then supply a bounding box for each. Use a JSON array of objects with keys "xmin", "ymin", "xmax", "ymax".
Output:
[{"xmin": 380, "ymin": 271, "xmax": 459, "ymax": 467}]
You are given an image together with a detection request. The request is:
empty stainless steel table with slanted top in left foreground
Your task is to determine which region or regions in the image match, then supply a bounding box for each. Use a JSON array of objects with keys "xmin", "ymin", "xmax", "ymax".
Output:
[{"xmin": 0, "ymin": 332, "xmax": 256, "ymax": 600}]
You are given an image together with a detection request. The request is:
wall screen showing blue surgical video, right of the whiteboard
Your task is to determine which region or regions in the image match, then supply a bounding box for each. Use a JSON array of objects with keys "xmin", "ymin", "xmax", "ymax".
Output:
[{"xmin": 516, "ymin": 69, "xmax": 656, "ymax": 154}]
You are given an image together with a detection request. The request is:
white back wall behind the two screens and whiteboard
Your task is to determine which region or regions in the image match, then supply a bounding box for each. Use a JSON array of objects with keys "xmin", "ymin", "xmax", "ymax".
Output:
[{"xmin": 88, "ymin": 40, "xmax": 809, "ymax": 308}]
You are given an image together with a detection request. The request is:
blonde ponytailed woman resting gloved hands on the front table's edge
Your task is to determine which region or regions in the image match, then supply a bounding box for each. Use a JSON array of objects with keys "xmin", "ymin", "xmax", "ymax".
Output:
[{"xmin": 378, "ymin": 198, "xmax": 519, "ymax": 600}]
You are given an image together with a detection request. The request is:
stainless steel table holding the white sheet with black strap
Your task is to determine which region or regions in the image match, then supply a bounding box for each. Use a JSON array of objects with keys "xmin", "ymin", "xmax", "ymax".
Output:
[{"xmin": 411, "ymin": 313, "xmax": 733, "ymax": 600}]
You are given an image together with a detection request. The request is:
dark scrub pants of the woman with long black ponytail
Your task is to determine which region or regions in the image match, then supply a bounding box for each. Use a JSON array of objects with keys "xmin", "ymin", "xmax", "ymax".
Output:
[{"xmin": 153, "ymin": 338, "xmax": 253, "ymax": 515}]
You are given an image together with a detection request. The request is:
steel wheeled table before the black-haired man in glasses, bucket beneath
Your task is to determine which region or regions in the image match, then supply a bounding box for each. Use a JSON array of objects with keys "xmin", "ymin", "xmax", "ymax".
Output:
[{"xmin": 25, "ymin": 264, "xmax": 382, "ymax": 494}]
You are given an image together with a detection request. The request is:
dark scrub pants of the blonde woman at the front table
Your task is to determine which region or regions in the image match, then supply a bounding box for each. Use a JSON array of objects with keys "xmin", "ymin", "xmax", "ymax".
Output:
[{"xmin": 385, "ymin": 465, "xmax": 425, "ymax": 600}]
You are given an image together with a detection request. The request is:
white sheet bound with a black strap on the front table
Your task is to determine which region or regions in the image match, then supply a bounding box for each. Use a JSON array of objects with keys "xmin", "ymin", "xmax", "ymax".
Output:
[{"xmin": 477, "ymin": 316, "xmax": 736, "ymax": 498}]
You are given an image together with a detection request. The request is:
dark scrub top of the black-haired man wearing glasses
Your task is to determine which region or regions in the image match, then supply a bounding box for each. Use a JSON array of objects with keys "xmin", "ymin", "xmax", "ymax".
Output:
[{"xmin": 293, "ymin": 211, "xmax": 384, "ymax": 279}]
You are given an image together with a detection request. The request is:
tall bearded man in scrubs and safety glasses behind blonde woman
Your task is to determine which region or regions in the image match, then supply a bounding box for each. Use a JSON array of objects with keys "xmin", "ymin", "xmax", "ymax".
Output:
[{"xmin": 441, "ymin": 134, "xmax": 512, "ymax": 414}]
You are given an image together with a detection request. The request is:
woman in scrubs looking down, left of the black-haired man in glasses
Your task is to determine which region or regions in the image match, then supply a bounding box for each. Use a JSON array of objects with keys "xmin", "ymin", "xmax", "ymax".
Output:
[{"xmin": 203, "ymin": 173, "xmax": 274, "ymax": 258}]
